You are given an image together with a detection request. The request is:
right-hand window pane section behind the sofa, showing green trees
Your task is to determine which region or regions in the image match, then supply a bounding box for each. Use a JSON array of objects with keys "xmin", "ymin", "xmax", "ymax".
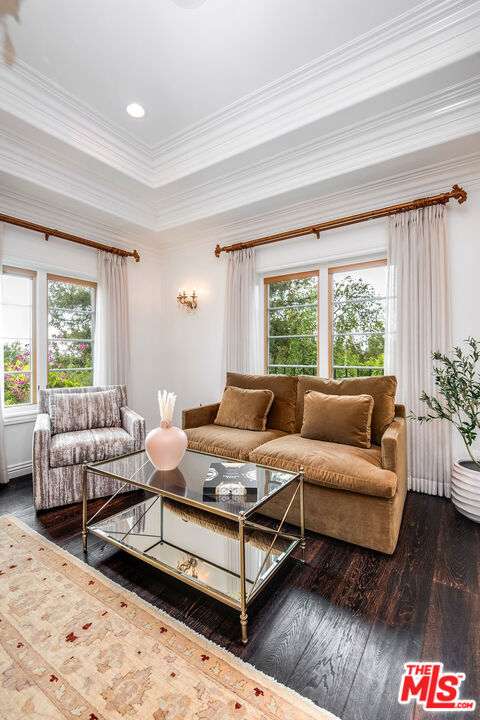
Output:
[{"xmin": 329, "ymin": 260, "xmax": 386, "ymax": 378}]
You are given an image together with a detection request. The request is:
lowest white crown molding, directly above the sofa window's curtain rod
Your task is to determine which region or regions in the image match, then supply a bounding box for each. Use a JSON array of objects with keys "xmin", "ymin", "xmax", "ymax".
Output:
[{"xmin": 161, "ymin": 152, "xmax": 480, "ymax": 260}]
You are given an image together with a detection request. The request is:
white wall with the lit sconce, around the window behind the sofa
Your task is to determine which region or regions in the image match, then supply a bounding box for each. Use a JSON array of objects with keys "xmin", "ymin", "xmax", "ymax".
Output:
[{"xmin": 162, "ymin": 177, "xmax": 480, "ymax": 457}]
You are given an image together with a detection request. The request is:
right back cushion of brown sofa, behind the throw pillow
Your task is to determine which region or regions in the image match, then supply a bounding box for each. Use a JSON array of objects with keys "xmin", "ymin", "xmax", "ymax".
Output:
[{"xmin": 296, "ymin": 375, "xmax": 397, "ymax": 445}]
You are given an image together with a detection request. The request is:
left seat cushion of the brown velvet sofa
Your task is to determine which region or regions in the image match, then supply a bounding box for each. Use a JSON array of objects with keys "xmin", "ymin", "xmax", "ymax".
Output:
[{"xmin": 185, "ymin": 425, "xmax": 285, "ymax": 460}]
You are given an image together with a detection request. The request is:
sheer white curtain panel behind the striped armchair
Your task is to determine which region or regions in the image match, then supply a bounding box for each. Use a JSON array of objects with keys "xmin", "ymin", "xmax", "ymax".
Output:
[{"xmin": 94, "ymin": 250, "xmax": 130, "ymax": 385}]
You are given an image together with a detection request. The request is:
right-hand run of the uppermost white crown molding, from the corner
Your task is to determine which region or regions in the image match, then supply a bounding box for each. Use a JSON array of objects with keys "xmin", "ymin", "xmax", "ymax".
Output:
[{"xmin": 153, "ymin": 0, "xmax": 480, "ymax": 186}]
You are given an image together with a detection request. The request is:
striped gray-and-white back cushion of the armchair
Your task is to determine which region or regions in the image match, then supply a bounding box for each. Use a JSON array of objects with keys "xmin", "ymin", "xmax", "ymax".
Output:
[{"xmin": 49, "ymin": 390, "xmax": 121, "ymax": 435}]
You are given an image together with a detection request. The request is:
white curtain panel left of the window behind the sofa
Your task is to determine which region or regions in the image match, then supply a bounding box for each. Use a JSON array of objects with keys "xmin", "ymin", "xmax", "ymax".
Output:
[{"xmin": 223, "ymin": 248, "xmax": 256, "ymax": 373}]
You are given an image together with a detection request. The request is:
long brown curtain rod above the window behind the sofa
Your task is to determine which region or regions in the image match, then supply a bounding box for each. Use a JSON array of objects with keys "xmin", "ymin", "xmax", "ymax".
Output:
[{"xmin": 215, "ymin": 185, "xmax": 467, "ymax": 257}]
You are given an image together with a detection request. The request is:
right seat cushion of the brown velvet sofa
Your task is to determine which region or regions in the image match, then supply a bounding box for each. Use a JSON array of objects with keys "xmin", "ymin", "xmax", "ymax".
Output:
[{"xmin": 249, "ymin": 434, "xmax": 397, "ymax": 498}]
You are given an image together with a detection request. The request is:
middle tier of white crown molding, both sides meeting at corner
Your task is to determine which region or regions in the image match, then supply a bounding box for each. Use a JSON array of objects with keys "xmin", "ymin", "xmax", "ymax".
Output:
[{"xmin": 0, "ymin": 76, "xmax": 480, "ymax": 232}]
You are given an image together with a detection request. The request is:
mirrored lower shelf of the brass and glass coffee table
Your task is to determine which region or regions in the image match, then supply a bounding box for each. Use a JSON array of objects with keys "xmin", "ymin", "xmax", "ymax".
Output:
[{"xmin": 84, "ymin": 495, "xmax": 305, "ymax": 643}]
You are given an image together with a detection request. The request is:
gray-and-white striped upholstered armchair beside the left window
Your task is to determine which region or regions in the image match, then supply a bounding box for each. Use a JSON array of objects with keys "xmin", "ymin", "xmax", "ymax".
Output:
[{"xmin": 33, "ymin": 385, "xmax": 145, "ymax": 510}]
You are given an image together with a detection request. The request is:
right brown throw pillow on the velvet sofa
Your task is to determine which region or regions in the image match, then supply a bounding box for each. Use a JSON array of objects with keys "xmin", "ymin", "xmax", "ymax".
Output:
[{"xmin": 300, "ymin": 390, "xmax": 373, "ymax": 448}]
